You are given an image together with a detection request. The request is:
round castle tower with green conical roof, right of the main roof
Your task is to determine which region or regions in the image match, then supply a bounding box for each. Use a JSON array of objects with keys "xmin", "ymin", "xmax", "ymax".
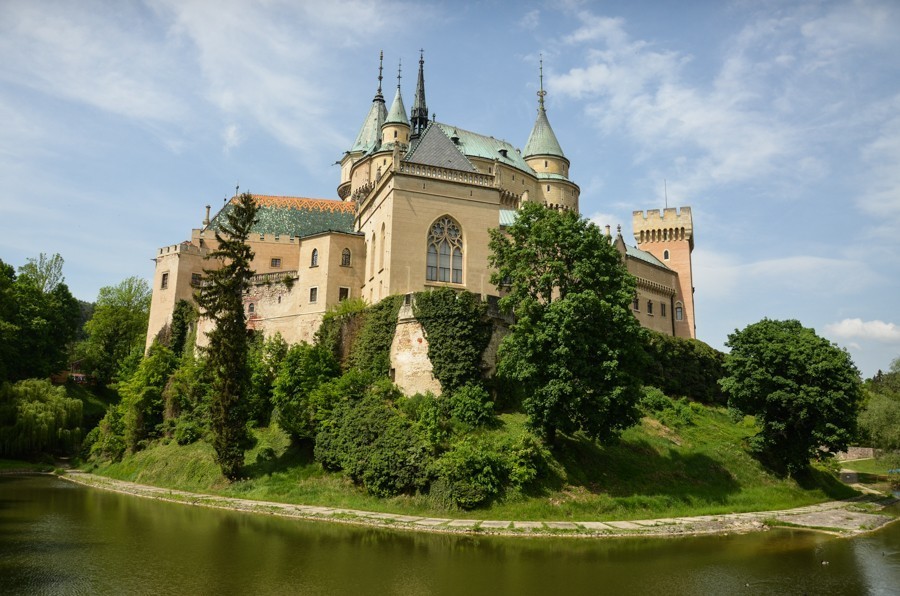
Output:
[{"xmin": 522, "ymin": 59, "xmax": 580, "ymax": 211}]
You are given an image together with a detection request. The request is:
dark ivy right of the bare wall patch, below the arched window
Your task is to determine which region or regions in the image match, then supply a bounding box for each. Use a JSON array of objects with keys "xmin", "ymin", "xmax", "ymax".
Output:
[{"xmin": 413, "ymin": 288, "xmax": 492, "ymax": 394}]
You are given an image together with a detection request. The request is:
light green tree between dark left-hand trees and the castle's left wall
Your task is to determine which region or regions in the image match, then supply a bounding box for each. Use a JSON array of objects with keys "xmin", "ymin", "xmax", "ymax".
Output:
[{"xmin": 75, "ymin": 277, "xmax": 150, "ymax": 383}]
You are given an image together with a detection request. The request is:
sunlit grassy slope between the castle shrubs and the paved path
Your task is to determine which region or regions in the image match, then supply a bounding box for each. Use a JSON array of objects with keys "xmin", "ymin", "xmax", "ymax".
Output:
[{"xmin": 81, "ymin": 402, "xmax": 856, "ymax": 521}]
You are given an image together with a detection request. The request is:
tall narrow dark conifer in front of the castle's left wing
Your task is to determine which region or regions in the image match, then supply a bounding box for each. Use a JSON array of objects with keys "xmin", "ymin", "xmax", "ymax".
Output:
[{"xmin": 197, "ymin": 193, "xmax": 258, "ymax": 479}]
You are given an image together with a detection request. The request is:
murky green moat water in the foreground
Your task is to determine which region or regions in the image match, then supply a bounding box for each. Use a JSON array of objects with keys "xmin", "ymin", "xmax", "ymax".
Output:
[{"xmin": 0, "ymin": 476, "xmax": 900, "ymax": 596}]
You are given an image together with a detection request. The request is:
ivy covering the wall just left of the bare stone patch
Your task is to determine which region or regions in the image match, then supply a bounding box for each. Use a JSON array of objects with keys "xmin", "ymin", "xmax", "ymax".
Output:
[{"xmin": 350, "ymin": 296, "xmax": 403, "ymax": 377}]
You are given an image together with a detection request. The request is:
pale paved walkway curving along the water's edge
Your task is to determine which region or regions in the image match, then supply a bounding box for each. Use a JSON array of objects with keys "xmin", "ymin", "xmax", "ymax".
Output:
[{"xmin": 61, "ymin": 470, "xmax": 897, "ymax": 538}]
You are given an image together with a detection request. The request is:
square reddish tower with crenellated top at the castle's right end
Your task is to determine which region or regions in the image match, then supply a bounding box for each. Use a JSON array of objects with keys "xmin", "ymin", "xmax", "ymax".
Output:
[{"xmin": 631, "ymin": 207, "xmax": 697, "ymax": 338}]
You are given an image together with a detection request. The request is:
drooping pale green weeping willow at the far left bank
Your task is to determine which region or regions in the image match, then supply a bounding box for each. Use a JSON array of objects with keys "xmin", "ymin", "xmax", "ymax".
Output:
[{"xmin": 0, "ymin": 379, "xmax": 82, "ymax": 457}]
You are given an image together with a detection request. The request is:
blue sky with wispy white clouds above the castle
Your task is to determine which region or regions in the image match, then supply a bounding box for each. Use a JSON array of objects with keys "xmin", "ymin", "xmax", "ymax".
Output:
[{"xmin": 0, "ymin": 0, "xmax": 900, "ymax": 376}]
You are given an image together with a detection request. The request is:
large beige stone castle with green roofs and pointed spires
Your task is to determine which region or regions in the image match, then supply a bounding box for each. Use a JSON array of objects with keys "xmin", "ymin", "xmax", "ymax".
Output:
[{"xmin": 147, "ymin": 54, "xmax": 695, "ymax": 392}]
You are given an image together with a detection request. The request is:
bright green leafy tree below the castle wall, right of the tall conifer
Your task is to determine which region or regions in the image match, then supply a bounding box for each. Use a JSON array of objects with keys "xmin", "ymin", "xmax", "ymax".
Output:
[{"xmin": 272, "ymin": 343, "xmax": 341, "ymax": 438}]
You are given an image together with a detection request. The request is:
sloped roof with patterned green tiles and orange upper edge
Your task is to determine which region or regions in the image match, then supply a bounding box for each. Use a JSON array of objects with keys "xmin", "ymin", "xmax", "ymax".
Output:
[{"xmin": 207, "ymin": 195, "xmax": 356, "ymax": 237}]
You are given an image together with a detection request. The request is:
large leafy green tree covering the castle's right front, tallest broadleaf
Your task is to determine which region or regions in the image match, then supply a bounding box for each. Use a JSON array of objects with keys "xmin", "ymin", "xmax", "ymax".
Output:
[{"xmin": 490, "ymin": 203, "xmax": 642, "ymax": 444}]
